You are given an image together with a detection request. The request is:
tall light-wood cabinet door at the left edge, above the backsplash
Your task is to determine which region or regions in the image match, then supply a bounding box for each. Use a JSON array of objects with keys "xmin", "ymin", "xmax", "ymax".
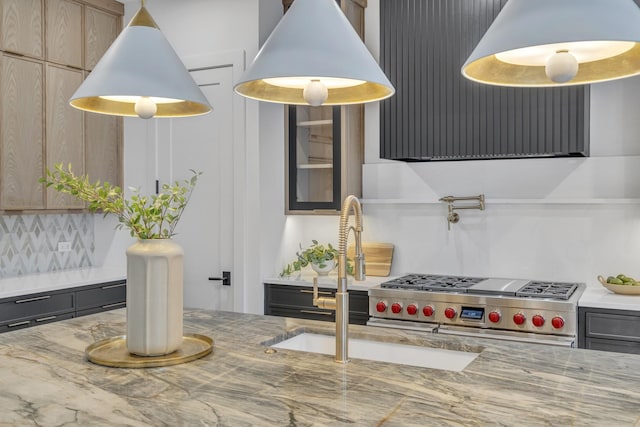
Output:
[{"xmin": 0, "ymin": 55, "xmax": 44, "ymax": 209}]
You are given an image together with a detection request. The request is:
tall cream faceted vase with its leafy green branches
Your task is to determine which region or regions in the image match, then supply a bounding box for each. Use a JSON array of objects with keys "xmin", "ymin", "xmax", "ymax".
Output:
[{"xmin": 40, "ymin": 164, "xmax": 201, "ymax": 356}]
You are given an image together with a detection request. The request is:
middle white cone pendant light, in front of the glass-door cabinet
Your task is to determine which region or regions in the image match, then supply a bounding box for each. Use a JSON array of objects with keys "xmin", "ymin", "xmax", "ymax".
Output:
[{"xmin": 235, "ymin": 0, "xmax": 395, "ymax": 106}]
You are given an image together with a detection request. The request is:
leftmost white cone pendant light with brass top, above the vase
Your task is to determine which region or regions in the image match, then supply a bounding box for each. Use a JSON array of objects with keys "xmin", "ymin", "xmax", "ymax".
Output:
[{"xmin": 69, "ymin": 2, "xmax": 211, "ymax": 119}]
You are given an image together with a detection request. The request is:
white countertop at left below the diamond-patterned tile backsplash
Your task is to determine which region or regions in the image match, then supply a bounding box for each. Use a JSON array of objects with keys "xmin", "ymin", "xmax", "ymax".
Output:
[{"xmin": 0, "ymin": 267, "xmax": 126, "ymax": 298}]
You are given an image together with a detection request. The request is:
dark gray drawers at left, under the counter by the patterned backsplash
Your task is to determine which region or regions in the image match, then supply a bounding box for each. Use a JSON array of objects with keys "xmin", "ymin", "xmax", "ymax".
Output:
[{"xmin": 0, "ymin": 280, "xmax": 127, "ymax": 332}]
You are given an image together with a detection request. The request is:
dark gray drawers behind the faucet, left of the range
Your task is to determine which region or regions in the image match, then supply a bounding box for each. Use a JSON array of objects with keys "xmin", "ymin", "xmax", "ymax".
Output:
[{"xmin": 264, "ymin": 283, "xmax": 369, "ymax": 325}]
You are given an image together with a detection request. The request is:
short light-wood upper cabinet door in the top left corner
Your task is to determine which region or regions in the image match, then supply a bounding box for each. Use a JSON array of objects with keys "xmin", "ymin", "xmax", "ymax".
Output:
[{"xmin": 0, "ymin": 0, "xmax": 44, "ymax": 59}]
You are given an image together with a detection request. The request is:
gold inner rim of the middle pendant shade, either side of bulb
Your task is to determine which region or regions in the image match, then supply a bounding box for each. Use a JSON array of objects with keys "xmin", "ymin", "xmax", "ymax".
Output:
[{"xmin": 235, "ymin": 80, "xmax": 393, "ymax": 105}]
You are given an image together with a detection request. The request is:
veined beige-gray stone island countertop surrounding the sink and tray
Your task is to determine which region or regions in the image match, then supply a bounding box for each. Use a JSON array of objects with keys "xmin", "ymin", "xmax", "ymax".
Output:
[{"xmin": 0, "ymin": 309, "xmax": 640, "ymax": 427}]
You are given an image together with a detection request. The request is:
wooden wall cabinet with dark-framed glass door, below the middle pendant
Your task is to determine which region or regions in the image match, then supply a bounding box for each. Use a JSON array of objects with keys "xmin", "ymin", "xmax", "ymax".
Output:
[{"xmin": 286, "ymin": 105, "xmax": 363, "ymax": 214}]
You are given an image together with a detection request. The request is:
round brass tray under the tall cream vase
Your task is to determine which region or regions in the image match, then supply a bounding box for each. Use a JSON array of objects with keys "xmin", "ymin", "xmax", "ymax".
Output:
[{"xmin": 85, "ymin": 334, "xmax": 213, "ymax": 368}]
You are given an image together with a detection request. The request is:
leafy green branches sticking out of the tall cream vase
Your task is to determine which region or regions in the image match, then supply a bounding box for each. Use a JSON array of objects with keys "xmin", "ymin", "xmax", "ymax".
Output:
[{"xmin": 40, "ymin": 163, "xmax": 202, "ymax": 239}]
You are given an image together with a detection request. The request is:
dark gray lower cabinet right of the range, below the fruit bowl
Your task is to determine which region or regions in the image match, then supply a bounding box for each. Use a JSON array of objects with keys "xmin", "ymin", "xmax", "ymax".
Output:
[{"xmin": 578, "ymin": 307, "xmax": 640, "ymax": 354}]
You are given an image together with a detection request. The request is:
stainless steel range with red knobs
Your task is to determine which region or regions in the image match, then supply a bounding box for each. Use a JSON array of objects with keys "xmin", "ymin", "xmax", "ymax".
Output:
[{"xmin": 368, "ymin": 274, "xmax": 585, "ymax": 346}]
